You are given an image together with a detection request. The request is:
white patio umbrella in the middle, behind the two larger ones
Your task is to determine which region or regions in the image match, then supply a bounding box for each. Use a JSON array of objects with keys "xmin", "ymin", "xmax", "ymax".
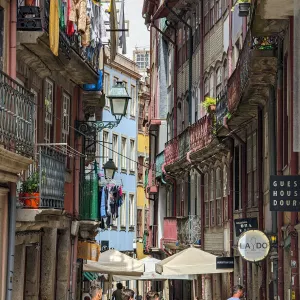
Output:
[{"xmin": 113, "ymin": 257, "xmax": 197, "ymax": 281}]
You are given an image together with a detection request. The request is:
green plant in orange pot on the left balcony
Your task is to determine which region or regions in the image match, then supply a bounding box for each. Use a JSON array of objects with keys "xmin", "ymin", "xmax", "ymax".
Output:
[{"xmin": 19, "ymin": 172, "xmax": 40, "ymax": 208}]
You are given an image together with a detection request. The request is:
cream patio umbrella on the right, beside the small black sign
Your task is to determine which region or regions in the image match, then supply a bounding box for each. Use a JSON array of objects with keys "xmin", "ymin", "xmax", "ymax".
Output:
[{"xmin": 155, "ymin": 247, "xmax": 233, "ymax": 276}]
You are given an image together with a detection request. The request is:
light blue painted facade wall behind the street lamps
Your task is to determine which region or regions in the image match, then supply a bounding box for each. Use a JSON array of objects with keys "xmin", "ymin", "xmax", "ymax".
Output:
[{"xmin": 96, "ymin": 65, "xmax": 138, "ymax": 251}]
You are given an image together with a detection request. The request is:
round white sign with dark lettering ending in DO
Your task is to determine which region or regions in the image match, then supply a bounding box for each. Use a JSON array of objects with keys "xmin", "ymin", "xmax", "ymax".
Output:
[{"xmin": 238, "ymin": 230, "xmax": 270, "ymax": 262}]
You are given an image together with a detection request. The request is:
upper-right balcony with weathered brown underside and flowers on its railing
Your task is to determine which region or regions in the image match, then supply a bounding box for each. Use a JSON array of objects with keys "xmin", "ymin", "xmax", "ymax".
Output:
[{"xmin": 227, "ymin": 30, "xmax": 277, "ymax": 129}]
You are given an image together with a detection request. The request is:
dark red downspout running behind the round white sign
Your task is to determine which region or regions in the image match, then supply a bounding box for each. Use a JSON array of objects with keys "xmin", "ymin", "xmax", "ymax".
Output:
[{"xmin": 254, "ymin": 108, "xmax": 267, "ymax": 300}]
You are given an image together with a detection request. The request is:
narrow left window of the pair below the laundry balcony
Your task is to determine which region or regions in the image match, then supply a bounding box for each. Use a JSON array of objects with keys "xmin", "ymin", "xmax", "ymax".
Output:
[{"xmin": 44, "ymin": 78, "xmax": 54, "ymax": 143}]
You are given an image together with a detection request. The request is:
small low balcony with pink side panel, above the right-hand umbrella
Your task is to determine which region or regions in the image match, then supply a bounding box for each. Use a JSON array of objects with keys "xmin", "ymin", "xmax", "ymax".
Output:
[{"xmin": 163, "ymin": 215, "xmax": 201, "ymax": 246}]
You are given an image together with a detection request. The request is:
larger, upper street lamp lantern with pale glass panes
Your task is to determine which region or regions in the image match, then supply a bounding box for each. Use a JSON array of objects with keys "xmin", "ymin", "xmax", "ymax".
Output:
[{"xmin": 107, "ymin": 81, "xmax": 131, "ymax": 121}]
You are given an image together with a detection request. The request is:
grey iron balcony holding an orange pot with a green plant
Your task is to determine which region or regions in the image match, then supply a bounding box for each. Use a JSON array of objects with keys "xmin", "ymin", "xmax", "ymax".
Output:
[{"xmin": 19, "ymin": 146, "xmax": 66, "ymax": 209}]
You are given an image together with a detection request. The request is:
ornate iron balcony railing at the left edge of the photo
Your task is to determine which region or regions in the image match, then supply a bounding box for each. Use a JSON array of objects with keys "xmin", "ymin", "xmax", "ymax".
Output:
[{"xmin": 0, "ymin": 71, "xmax": 35, "ymax": 157}]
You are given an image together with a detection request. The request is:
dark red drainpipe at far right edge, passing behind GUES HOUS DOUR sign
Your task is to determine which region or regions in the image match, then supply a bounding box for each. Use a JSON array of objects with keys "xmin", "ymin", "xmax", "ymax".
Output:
[{"xmin": 289, "ymin": 17, "xmax": 299, "ymax": 299}]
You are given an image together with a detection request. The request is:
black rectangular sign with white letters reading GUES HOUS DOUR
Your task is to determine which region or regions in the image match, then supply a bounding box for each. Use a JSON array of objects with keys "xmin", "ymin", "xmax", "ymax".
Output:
[{"xmin": 270, "ymin": 175, "xmax": 300, "ymax": 211}]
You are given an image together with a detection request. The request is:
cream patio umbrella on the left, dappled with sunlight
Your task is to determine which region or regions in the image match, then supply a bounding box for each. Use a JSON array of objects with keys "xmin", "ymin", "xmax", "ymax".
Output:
[{"xmin": 83, "ymin": 250, "xmax": 145, "ymax": 276}]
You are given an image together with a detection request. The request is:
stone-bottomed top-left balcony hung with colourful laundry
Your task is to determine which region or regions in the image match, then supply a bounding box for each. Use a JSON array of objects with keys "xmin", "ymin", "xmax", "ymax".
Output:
[{"xmin": 17, "ymin": 0, "xmax": 101, "ymax": 84}]
